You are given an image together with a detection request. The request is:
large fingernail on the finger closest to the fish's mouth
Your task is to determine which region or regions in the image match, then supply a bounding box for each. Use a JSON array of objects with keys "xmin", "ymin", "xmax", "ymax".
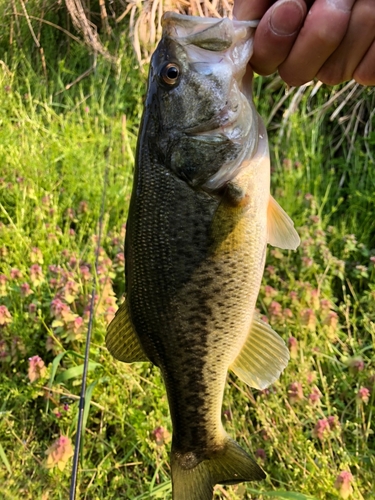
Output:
[{"xmin": 269, "ymin": 0, "xmax": 305, "ymax": 36}]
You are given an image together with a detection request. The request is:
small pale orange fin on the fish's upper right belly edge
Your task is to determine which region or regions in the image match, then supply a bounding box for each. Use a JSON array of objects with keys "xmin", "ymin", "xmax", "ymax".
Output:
[{"xmin": 267, "ymin": 196, "xmax": 301, "ymax": 250}]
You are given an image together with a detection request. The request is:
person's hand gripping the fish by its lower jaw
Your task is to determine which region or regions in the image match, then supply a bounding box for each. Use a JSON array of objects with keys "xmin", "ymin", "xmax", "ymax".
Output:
[{"xmin": 233, "ymin": 0, "xmax": 375, "ymax": 86}]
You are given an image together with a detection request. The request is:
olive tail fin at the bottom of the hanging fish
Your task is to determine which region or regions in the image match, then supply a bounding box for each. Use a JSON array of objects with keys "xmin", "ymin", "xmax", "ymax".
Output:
[{"xmin": 171, "ymin": 438, "xmax": 266, "ymax": 500}]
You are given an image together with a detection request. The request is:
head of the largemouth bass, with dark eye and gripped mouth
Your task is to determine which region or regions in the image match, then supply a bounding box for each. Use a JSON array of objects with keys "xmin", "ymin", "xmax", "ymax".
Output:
[{"xmin": 144, "ymin": 12, "xmax": 258, "ymax": 192}]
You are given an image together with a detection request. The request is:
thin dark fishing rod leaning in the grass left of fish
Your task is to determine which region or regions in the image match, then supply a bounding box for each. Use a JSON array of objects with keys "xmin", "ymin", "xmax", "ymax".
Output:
[{"xmin": 69, "ymin": 141, "xmax": 112, "ymax": 500}]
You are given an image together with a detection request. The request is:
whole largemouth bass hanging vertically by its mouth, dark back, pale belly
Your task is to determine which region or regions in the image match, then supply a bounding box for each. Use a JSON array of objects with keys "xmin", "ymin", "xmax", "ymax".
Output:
[{"xmin": 106, "ymin": 12, "xmax": 300, "ymax": 500}]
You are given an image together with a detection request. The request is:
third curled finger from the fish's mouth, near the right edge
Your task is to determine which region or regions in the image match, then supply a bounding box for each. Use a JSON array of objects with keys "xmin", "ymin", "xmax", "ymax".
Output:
[{"xmin": 317, "ymin": 0, "xmax": 375, "ymax": 85}]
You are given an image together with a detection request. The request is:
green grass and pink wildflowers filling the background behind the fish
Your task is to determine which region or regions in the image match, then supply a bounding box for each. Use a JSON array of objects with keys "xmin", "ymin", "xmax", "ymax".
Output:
[{"xmin": 0, "ymin": 0, "xmax": 375, "ymax": 500}]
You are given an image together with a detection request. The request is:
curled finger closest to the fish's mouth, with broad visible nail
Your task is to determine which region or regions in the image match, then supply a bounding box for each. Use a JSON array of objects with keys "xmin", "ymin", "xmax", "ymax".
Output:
[{"xmin": 250, "ymin": 0, "xmax": 307, "ymax": 75}]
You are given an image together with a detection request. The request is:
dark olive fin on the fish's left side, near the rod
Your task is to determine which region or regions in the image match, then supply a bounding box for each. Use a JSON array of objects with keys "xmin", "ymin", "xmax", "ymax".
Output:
[{"xmin": 105, "ymin": 300, "xmax": 149, "ymax": 363}]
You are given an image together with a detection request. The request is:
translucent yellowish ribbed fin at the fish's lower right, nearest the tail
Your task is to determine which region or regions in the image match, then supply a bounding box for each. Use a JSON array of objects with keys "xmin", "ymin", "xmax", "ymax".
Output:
[{"xmin": 230, "ymin": 318, "xmax": 289, "ymax": 389}]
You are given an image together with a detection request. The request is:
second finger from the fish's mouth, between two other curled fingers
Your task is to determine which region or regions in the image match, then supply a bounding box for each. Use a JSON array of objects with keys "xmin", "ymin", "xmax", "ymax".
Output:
[{"xmin": 279, "ymin": 0, "xmax": 355, "ymax": 86}]
